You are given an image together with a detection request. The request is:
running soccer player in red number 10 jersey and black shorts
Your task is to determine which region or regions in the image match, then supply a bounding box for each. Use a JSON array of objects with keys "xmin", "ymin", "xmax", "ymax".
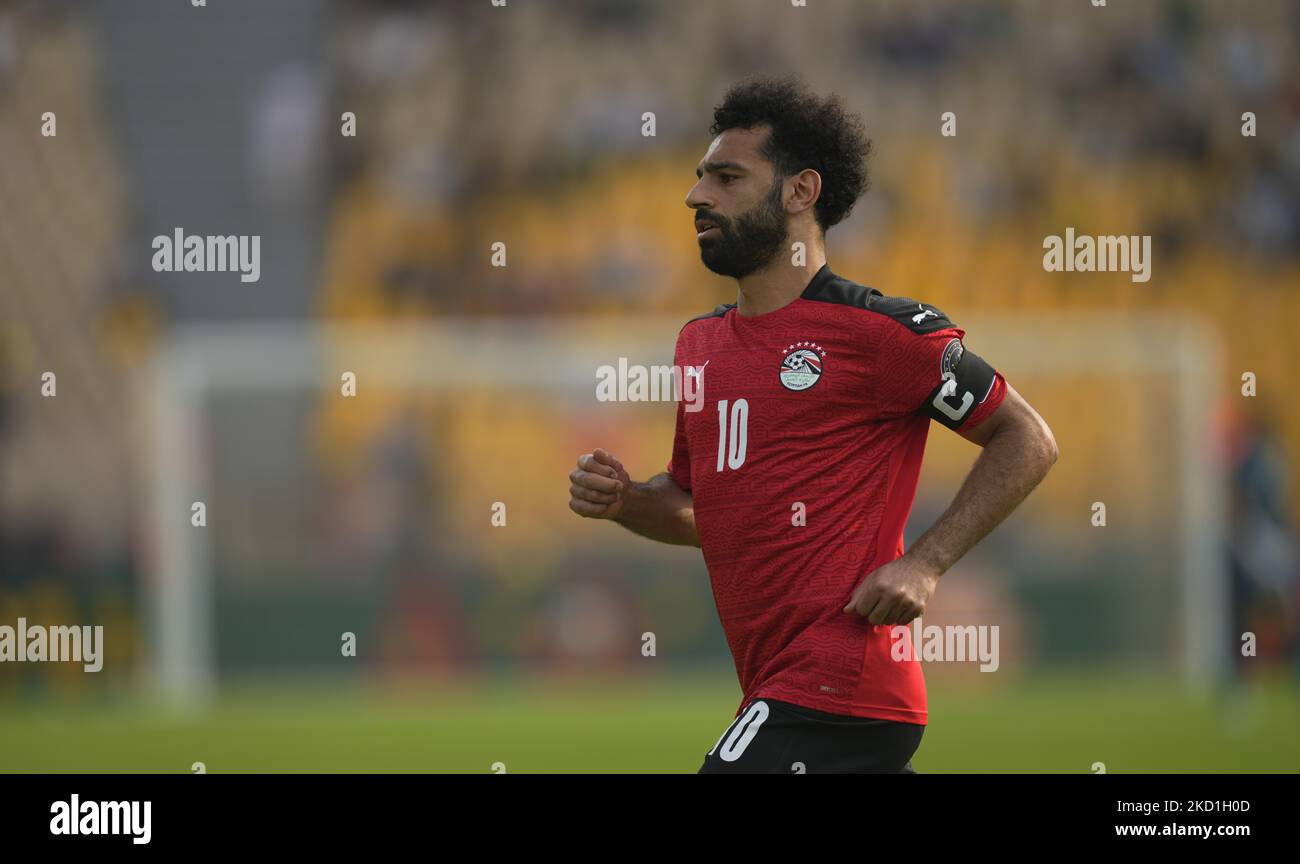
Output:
[{"xmin": 569, "ymin": 78, "xmax": 1057, "ymax": 773}]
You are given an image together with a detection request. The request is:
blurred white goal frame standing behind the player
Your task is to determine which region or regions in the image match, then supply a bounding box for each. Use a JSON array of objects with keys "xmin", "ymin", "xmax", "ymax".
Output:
[{"xmin": 144, "ymin": 311, "xmax": 1230, "ymax": 709}]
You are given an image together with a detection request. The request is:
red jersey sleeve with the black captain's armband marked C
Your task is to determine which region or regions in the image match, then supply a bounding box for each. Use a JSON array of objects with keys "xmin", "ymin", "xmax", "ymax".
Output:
[{"xmin": 880, "ymin": 321, "xmax": 1006, "ymax": 431}]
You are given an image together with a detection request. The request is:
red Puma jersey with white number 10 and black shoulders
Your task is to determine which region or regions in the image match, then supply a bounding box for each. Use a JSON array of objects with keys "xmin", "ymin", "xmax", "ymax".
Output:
[{"xmin": 668, "ymin": 266, "xmax": 1006, "ymax": 724}]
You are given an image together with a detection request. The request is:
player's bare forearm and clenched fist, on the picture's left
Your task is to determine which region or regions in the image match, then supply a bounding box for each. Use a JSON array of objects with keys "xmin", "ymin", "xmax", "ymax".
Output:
[{"xmin": 569, "ymin": 448, "xmax": 699, "ymax": 547}]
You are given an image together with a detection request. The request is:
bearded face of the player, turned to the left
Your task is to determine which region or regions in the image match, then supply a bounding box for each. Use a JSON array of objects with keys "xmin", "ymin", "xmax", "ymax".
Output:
[{"xmin": 686, "ymin": 126, "xmax": 789, "ymax": 279}]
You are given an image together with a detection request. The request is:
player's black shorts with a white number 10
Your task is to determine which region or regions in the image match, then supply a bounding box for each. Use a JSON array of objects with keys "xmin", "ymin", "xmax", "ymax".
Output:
[{"xmin": 698, "ymin": 699, "xmax": 926, "ymax": 774}]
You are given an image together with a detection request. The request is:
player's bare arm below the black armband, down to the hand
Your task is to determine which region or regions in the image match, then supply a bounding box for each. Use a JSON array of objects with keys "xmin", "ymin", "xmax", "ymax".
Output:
[{"xmin": 844, "ymin": 385, "xmax": 1057, "ymax": 625}]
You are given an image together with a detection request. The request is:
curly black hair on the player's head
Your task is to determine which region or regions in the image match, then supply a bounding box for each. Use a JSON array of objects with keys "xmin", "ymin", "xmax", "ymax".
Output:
[{"xmin": 709, "ymin": 75, "xmax": 871, "ymax": 233}]
